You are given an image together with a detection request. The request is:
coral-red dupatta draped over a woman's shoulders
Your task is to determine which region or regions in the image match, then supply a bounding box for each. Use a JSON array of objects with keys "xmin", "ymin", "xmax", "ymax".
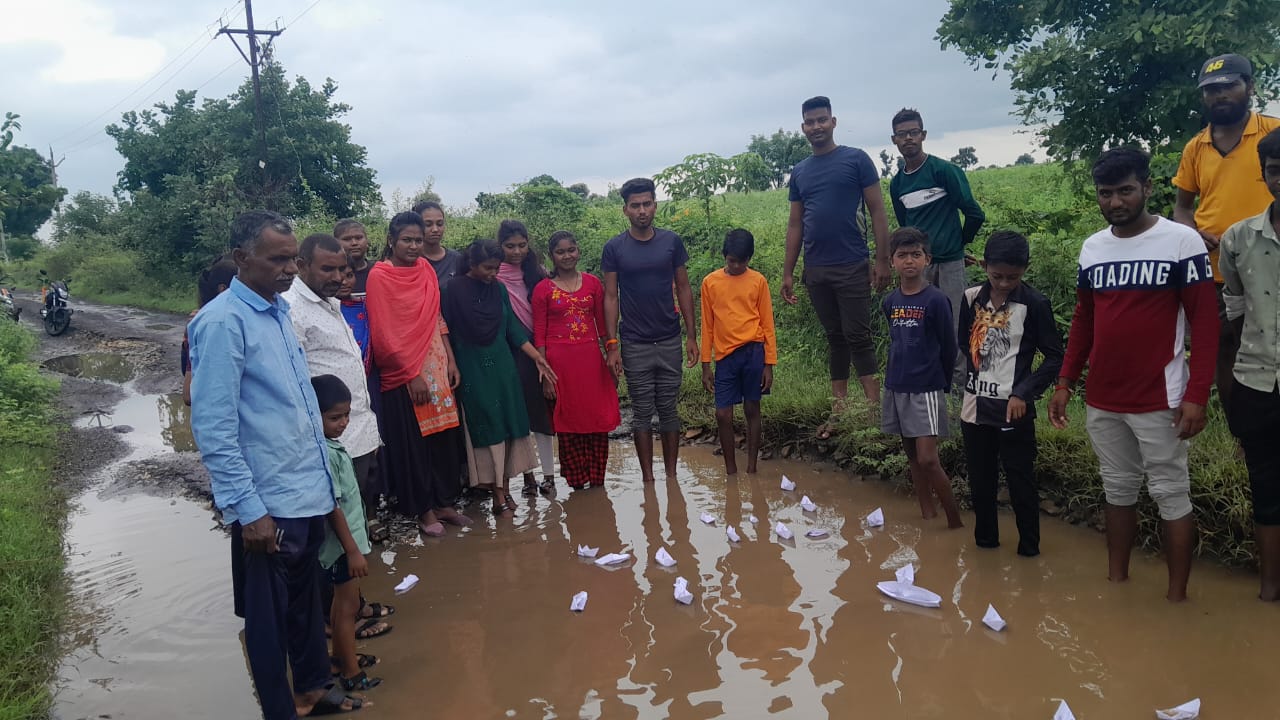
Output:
[{"xmin": 365, "ymin": 258, "xmax": 440, "ymax": 392}]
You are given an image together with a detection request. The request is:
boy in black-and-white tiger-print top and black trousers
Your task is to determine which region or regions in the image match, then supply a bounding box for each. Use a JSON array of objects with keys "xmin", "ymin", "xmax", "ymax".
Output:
[{"xmin": 960, "ymin": 231, "xmax": 1062, "ymax": 557}]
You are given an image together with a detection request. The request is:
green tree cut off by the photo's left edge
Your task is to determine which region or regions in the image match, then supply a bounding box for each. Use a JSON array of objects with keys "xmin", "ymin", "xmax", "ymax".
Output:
[{"xmin": 0, "ymin": 113, "xmax": 67, "ymax": 234}]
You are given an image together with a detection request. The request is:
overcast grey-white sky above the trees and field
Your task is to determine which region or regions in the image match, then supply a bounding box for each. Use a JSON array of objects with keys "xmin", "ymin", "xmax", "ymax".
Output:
[{"xmin": 0, "ymin": 0, "xmax": 1042, "ymax": 206}]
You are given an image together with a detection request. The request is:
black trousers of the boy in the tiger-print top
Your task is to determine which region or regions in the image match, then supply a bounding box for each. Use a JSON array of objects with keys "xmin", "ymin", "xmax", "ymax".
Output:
[{"xmin": 960, "ymin": 418, "xmax": 1039, "ymax": 556}]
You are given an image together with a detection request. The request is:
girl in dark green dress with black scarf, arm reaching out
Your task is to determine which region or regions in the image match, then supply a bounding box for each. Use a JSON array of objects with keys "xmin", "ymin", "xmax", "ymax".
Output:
[{"xmin": 443, "ymin": 240, "xmax": 556, "ymax": 518}]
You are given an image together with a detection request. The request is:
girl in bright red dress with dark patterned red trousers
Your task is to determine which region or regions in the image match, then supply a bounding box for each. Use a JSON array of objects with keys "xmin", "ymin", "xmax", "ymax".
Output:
[{"xmin": 532, "ymin": 231, "xmax": 621, "ymax": 489}]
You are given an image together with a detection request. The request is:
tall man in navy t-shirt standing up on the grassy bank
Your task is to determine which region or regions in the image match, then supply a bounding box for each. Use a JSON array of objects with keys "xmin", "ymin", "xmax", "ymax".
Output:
[{"xmin": 782, "ymin": 96, "xmax": 892, "ymax": 439}]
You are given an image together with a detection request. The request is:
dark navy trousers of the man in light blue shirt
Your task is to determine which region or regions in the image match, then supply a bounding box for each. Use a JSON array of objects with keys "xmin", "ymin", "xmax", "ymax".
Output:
[{"xmin": 244, "ymin": 516, "xmax": 329, "ymax": 720}]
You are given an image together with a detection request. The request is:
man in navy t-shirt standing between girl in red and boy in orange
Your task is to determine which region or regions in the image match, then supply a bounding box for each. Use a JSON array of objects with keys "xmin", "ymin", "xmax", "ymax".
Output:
[{"xmin": 600, "ymin": 178, "xmax": 699, "ymax": 483}]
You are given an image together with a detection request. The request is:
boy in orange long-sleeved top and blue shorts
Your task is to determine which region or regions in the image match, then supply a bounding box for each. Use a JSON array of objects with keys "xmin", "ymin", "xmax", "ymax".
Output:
[{"xmin": 701, "ymin": 228, "xmax": 778, "ymax": 475}]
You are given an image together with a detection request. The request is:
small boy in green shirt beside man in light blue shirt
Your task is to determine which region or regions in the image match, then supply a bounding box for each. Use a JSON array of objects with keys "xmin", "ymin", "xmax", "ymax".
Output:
[{"xmin": 311, "ymin": 375, "xmax": 381, "ymax": 691}]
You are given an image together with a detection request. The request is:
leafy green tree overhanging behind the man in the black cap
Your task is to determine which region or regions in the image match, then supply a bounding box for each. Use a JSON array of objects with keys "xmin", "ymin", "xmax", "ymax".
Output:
[{"xmin": 937, "ymin": 0, "xmax": 1280, "ymax": 160}]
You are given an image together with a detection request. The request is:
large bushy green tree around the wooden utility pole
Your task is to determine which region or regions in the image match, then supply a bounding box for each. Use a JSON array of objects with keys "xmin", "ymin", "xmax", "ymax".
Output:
[{"xmin": 106, "ymin": 60, "xmax": 380, "ymax": 271}]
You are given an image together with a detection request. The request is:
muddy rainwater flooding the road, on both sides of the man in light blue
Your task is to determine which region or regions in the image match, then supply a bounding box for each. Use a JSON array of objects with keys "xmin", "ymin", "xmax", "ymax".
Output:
[{"xmin": 49, "ymin": 356, "xmax": 1280, "ymax": 720}]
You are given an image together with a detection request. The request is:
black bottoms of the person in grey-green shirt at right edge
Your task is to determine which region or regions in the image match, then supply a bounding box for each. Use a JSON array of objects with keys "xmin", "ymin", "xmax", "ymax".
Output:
[{"xmin": 1226, "ymin": 380, "xmax": 1280, "ymax": 525}]
